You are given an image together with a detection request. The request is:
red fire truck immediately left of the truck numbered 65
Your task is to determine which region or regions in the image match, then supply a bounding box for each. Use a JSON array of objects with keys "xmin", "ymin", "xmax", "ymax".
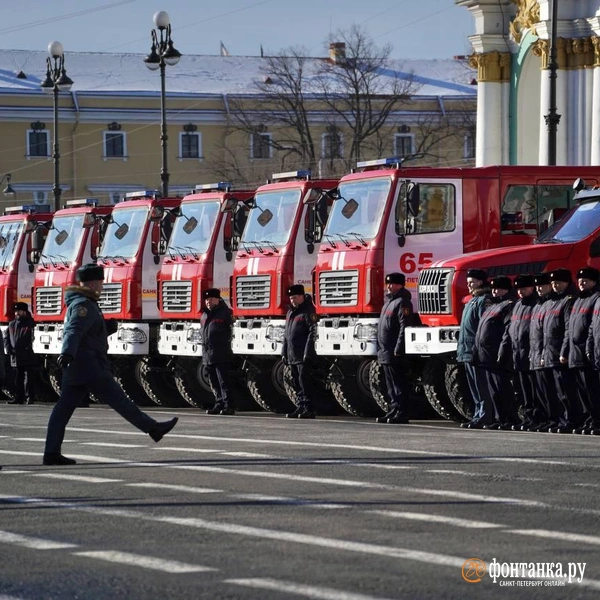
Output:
[{"xmin": 232, "ymin": 171, "xmax": 337, "ymax": 412}]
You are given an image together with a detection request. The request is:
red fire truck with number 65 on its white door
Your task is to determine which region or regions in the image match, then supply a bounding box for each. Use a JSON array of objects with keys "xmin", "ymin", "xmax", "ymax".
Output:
[{"xmin": 315, "ymin": 159, "xmax": 600, "ymax": 418}]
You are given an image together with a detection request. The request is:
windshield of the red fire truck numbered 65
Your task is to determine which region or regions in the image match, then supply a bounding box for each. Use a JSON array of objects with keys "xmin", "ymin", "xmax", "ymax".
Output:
[{"xmin": 324, "ymin": 178, "xmax": 392, "ymax": 240}]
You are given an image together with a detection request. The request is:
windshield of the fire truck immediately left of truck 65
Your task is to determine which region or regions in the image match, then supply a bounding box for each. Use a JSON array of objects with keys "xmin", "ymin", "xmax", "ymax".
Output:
[{"xmin": 241, "ymin": 188, "xmax": 301, "ymax": 246}]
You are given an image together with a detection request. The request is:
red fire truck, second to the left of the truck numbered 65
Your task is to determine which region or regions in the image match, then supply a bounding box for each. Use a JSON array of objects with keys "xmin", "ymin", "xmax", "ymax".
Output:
[{"xmin": 158, "ymin": 182, "xmax": 254, "ymax": 407}]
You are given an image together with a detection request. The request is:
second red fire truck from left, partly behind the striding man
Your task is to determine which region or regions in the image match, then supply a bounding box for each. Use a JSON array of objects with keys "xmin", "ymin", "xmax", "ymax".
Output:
[{"xmin": 32, "ymin": 198, "xmax": 112, "ymax": 394}]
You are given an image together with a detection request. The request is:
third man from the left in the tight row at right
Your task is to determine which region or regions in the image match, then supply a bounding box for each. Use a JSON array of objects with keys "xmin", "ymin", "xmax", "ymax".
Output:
[{"xmin": 498, "ymin": 275, "xmax": 543, "ymax": 431}]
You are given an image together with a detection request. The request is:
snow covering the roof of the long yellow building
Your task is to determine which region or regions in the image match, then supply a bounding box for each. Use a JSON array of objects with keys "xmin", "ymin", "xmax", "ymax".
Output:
[{"xmin": 0, "ymin": 50, "xmax": 477, "ymax": 97}]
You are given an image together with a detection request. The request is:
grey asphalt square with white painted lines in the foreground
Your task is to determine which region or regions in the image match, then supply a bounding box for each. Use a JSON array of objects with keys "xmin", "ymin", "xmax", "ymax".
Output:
[{"xmin": 0, "ymin": 404, "xmax": 600, "ymax": 600}]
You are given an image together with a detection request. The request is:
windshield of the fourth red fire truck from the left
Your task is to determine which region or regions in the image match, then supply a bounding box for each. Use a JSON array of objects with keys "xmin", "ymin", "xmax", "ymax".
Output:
[{"xmin": 169, "ymin": 200, "xmax": 219, "ymax": 254}]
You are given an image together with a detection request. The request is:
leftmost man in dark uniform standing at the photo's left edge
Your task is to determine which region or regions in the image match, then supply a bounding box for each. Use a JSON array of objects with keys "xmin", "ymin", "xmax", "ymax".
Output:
[{"xmin": 2, "ymin": 302, "xmax": 39, "ymax": 404}]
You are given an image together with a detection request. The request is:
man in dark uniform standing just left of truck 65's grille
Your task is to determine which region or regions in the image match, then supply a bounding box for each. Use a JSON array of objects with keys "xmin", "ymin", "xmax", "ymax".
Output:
[{"xmin": 281, "ymin": 284, "xmax": 317, "ymax": 419}]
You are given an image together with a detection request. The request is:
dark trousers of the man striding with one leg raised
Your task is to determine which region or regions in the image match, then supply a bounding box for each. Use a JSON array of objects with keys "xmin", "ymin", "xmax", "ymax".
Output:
[{"xmin": 45, "ymin": 371, "xmax": 156, "ymax": 454}]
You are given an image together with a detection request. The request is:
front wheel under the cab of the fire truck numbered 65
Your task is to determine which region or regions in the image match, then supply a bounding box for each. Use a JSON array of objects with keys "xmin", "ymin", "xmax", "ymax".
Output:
[{"xmin": 329, "ymin": 359, "xmax": 381, "ymax": 417}]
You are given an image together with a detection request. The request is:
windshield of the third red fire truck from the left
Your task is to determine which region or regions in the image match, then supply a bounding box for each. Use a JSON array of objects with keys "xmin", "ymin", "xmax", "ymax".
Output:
[{"xmin": 99, "ymin": 206, "xmax": 149, "ymax": 258}]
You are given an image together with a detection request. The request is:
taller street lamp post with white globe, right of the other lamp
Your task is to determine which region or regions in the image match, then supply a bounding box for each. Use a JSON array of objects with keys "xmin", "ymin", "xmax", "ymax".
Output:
[{"xmin": 144, "ymin": 10, "xmax": 181, "ymax": 198}]
